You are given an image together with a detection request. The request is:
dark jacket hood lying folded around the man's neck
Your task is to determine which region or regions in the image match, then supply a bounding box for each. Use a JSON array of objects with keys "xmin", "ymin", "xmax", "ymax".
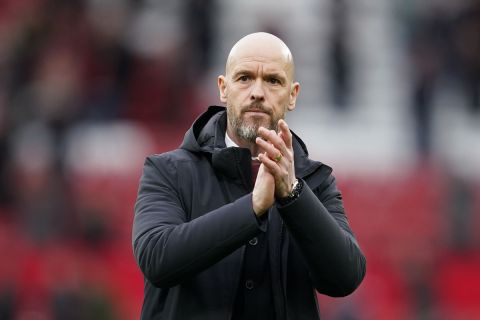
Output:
[{"xmin": 180, "ymin": 106, "xmax": 331, "ymax": 178}]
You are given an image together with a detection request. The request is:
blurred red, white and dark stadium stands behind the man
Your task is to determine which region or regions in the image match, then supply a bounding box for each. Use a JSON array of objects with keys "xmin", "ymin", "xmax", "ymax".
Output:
[{"xmin": 0, "ymin": 0, "xmax": 480, "ymax": 320}]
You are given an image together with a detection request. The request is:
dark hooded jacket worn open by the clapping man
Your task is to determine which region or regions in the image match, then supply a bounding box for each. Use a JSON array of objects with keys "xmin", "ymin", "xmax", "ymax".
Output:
[{"xmin": 133, "ymin": 107, "xmax": 365, "ymax": 320}]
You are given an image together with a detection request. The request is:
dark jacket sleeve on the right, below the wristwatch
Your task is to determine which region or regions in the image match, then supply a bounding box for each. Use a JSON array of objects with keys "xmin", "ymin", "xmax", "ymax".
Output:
[{"xmin": 278, "ymin": 175, "xmax": 366, "ymax": 297}]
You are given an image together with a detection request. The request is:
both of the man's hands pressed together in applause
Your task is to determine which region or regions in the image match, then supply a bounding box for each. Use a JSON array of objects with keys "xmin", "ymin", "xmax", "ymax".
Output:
[{"xmin": 252, "ymin": 119, "xmax": 296, "ymax": 216}]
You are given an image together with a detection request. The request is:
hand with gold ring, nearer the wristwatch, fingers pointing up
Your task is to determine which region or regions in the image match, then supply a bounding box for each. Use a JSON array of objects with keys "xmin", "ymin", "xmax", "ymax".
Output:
[{"xmin": 256, "ymin": 120, "xmax": 295, "ymax": 198}]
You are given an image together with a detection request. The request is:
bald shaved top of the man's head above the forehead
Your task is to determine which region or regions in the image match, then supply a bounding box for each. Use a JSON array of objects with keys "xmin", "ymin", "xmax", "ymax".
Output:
[{"xmin": 225, "ymin": 32, "xmax": 295, "ymax": 80}]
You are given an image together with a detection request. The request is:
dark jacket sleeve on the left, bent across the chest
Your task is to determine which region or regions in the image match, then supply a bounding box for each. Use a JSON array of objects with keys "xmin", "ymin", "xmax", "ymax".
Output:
[{"xmin": 132, "ymin": 156, "xmax": 263, "ymax": 287}]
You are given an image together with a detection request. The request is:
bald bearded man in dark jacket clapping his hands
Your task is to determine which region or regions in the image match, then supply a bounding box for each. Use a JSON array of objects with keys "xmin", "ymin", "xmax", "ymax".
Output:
[{"xmin": 133, "ymin": 33, "xmax": 365, "ymax": 320}]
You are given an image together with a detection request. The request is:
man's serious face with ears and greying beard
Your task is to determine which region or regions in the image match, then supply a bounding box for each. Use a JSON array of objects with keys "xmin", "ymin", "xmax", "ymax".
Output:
[{"xmin": 218, "ymin": 36, "xmax": 299, "ymax": 143}]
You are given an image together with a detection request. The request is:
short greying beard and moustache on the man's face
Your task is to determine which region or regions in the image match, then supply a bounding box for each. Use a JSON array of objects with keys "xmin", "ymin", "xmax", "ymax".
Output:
[{"xmin": 227, "ymin": 102, "xmax": 284, "ymax": 143}]
